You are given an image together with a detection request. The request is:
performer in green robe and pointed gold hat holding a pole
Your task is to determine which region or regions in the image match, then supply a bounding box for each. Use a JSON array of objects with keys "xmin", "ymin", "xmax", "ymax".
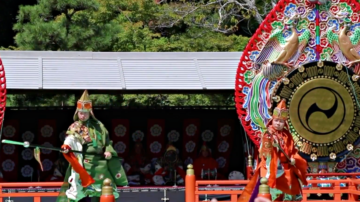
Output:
[{"xmin": 58, "ymin": 90, "xmax": 128, "ymax": 202}]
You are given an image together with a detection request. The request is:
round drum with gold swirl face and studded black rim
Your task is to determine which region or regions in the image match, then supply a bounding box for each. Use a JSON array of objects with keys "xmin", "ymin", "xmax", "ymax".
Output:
[{"xmin": 270, "ymin": 62, "xmax": 360, "ymax": 160}]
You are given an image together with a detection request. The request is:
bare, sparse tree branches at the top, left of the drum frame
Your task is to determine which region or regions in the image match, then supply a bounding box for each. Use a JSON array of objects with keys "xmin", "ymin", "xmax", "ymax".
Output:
[{"xmin": 152, "ymin": 0, "xmax": 276, "ymax": 33}]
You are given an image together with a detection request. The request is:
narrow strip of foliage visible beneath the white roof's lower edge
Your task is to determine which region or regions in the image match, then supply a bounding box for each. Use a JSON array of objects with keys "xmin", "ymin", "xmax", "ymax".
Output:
[{"xmin": 6, "ymin": 93, "xmax": 235, "ymax": 107}]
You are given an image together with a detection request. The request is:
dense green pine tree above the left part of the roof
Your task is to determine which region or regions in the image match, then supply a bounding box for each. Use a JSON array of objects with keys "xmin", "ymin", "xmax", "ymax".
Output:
[{"xmin": 14, "ymin": 0, "xmax": 121, "ymax": 51}]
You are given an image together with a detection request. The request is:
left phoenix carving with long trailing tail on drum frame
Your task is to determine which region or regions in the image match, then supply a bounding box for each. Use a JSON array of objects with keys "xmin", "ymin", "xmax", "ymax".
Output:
[{"xmin": 243, "ymin": 12, "xmax": 310, "ymax": 128}]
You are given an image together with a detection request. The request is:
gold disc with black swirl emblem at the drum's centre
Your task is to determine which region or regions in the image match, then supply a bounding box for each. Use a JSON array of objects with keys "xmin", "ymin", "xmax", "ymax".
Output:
[{"xmin": 289, "ymin": 78, "xmax": 355, "ymax": 143}]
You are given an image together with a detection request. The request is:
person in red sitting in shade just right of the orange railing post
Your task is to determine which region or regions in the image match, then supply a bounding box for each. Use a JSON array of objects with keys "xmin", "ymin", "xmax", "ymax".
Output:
[{"xmin": 194, "ymin": 142, "xmax": 218, "ymax": 179}]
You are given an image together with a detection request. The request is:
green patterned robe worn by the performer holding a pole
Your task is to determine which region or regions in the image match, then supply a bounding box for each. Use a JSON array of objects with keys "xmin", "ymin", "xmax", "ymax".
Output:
[{"xmin": 58, "ymin": 117, "xmax": 128, "ymax": 202}]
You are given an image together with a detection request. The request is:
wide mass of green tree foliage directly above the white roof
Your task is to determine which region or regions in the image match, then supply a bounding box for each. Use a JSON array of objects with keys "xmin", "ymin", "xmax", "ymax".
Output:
[{"xmin": 14, "ymin": 0, "xmax": 248, "ymax": 52}]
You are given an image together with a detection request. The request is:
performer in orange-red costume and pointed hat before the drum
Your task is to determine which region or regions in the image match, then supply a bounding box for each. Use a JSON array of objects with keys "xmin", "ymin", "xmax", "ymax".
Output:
[{"xmin": 238, "ymin": 100, "xmax": 308, "ymax": 202}]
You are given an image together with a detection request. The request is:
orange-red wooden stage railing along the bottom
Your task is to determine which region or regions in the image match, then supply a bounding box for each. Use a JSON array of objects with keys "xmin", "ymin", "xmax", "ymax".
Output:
[{"xmin": 0, "ymin": 165, "xmax": 360, "ymax": 202}]
